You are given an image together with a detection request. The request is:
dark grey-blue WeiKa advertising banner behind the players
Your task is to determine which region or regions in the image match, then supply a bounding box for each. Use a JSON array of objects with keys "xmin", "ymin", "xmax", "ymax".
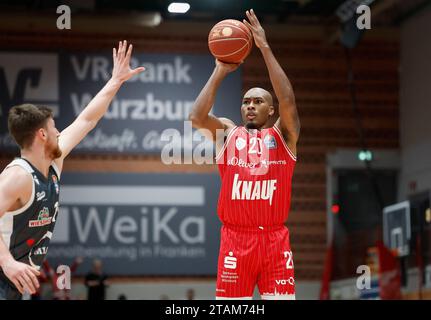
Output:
[{"xmin": 47, "ymin": 173, "xmax": 221, "ymax": 276}]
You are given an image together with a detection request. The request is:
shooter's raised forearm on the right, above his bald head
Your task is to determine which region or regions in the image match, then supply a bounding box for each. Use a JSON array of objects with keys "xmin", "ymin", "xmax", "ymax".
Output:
[{"xmin": 260, "ymin": 45, "xmax": 295, "ymax": 106}]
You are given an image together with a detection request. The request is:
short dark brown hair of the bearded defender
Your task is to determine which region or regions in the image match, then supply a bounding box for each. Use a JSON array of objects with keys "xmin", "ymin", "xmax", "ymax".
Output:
[{"xmin": 8, "ymin": 103, "xmax": 53, "ymax": 149}]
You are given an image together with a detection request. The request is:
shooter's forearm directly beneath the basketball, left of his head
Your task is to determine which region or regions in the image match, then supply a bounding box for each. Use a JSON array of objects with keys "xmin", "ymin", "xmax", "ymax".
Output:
[{"xmin": 189, "ymin": 67, "xmax": 226, "ymax": 127}]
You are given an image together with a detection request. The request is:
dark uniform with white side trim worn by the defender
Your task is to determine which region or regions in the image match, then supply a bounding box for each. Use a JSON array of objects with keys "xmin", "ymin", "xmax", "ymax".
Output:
[{"xmin": 0, "ymin": 158, "xmax": 60, "ymax": 300}]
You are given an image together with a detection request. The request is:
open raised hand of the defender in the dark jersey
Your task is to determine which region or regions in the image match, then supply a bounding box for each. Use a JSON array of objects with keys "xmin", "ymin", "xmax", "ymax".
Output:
[{"xmin": 112, "ymin": 40, "xmax": 145, "ymax": 83}]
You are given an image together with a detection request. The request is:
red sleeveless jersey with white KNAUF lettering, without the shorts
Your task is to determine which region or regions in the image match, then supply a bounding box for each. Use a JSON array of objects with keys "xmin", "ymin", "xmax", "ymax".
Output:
[{"xmin": 216, "ymin": 126, "xmax": 296, "ymax": 227}]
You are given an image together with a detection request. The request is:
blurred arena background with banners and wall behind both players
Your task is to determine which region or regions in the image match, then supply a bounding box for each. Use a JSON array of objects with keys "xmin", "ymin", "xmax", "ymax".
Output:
[{"xmin": 0, "ymin": 0, "xmax": 431, "ymax": 300}]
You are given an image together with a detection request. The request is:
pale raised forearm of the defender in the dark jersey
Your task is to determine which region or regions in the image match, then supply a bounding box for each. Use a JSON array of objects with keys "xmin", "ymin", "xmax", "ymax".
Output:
[{"xmin": 78, "ymin": 78, "xmax": 122, "ymax": 127}]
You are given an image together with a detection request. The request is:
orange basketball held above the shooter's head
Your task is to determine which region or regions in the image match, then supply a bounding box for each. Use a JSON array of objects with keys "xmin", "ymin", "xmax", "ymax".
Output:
[{"xmin": 208, "ymin": 19, "xmax": 253, "ymax": 63}]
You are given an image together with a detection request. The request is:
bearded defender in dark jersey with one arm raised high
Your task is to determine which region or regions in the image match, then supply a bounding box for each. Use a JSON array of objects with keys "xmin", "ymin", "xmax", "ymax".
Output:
[{"xmin": 0, "ymin": 41, "xmax": 144, "ymax": 300}]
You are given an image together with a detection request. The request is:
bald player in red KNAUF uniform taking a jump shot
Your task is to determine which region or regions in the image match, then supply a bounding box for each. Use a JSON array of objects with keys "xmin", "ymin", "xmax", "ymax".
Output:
[{"xmin": 189, "ymin": 10, "xmax": 300, "ymax": 300}]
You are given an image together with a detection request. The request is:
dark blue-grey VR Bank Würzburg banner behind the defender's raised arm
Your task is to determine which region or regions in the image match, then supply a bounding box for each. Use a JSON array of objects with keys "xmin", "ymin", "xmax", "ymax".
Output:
[{"xmin": 0, "ymin": 50, "xmax": 241, "ymax": 154}]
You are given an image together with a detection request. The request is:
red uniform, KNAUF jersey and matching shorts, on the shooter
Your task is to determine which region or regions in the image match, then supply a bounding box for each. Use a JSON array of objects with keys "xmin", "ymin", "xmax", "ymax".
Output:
[{"xmin": 216, "ymin": 126, "xmax": 296, "ymax": 299}]
